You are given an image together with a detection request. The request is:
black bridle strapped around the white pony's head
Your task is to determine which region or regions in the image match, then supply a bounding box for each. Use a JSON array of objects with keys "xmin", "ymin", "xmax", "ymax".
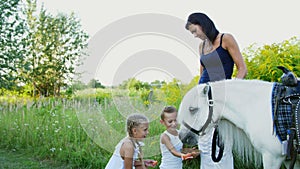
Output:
[{"xmin": 182, "ymin": 84, "xmax": 214, "ymax": 136}]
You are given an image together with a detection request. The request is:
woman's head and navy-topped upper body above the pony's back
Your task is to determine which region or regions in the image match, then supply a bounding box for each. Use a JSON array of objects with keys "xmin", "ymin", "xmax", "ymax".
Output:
[{"xmin": 186, "ymin": 13, "xmax": 247, "ymax": 83}]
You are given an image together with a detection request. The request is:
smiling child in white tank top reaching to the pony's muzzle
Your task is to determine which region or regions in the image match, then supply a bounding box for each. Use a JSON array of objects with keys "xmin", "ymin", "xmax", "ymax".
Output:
[{"xmin": 159, "ymin": 106, "xmax": 193, "ymax": 169}]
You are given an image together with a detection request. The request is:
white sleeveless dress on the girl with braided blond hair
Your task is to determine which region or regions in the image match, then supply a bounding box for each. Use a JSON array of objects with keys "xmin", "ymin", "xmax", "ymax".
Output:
[{"xmin": 105, "ymin": 138, "xmax": 139, "ymax": 169}]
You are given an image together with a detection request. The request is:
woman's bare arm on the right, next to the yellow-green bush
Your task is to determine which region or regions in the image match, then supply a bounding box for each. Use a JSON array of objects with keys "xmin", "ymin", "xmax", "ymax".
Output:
[{"xmin": 222, "ymin": 34, "xmax": 247, "ymax": 79}]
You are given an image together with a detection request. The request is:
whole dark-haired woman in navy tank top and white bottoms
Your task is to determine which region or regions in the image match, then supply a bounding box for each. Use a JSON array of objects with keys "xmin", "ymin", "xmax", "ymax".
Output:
[{"xmin": 186, "ymin": 13, "xmax": 247, "ymax": 169}]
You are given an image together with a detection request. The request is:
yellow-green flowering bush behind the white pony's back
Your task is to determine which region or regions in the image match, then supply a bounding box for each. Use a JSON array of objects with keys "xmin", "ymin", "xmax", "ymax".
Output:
[{"xmin": 243, "ymin": 37, "xmax": 300, "ymax": 82}]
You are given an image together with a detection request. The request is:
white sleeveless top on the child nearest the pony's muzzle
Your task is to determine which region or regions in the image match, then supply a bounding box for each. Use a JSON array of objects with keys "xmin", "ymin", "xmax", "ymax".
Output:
[{"xmin": 159, "ymin": 131, "xmax": 183, "ymax": 169}]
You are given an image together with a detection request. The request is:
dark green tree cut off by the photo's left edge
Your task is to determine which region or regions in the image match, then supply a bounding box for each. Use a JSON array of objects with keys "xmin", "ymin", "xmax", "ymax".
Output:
[{"xmin": 0, "ymin": 0, "xmax": 25, "ymax": 89}]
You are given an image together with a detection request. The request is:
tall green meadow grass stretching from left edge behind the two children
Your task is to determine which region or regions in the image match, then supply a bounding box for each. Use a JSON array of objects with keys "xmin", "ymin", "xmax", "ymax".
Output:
[{"xmin": 0, "ymin": 97, "xmax": 264, "ymax": 169}]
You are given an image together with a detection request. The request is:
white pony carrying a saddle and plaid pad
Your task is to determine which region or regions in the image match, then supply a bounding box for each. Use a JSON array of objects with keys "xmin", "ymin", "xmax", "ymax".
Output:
[{"xmin": 178, "ymin": 80, "xmax": 300, "ymax": 169}]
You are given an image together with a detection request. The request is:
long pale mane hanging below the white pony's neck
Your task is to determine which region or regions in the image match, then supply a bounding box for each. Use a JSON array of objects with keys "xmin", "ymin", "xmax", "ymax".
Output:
[{"xmin": 218, "ymin": 119, "xmax": 262, "ymax": 167}]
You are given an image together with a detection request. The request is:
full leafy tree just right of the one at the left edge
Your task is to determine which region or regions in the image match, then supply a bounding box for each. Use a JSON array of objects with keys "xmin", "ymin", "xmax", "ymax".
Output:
[{"xmin": 21, "ymin": 0, "xmax": 88, "ymax": 96}]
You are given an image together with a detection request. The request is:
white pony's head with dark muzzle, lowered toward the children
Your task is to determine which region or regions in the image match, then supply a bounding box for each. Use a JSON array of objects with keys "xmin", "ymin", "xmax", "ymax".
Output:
[{"xmin": 178, "ymin": 84, "xmax": 218, "ymax": 145}]
